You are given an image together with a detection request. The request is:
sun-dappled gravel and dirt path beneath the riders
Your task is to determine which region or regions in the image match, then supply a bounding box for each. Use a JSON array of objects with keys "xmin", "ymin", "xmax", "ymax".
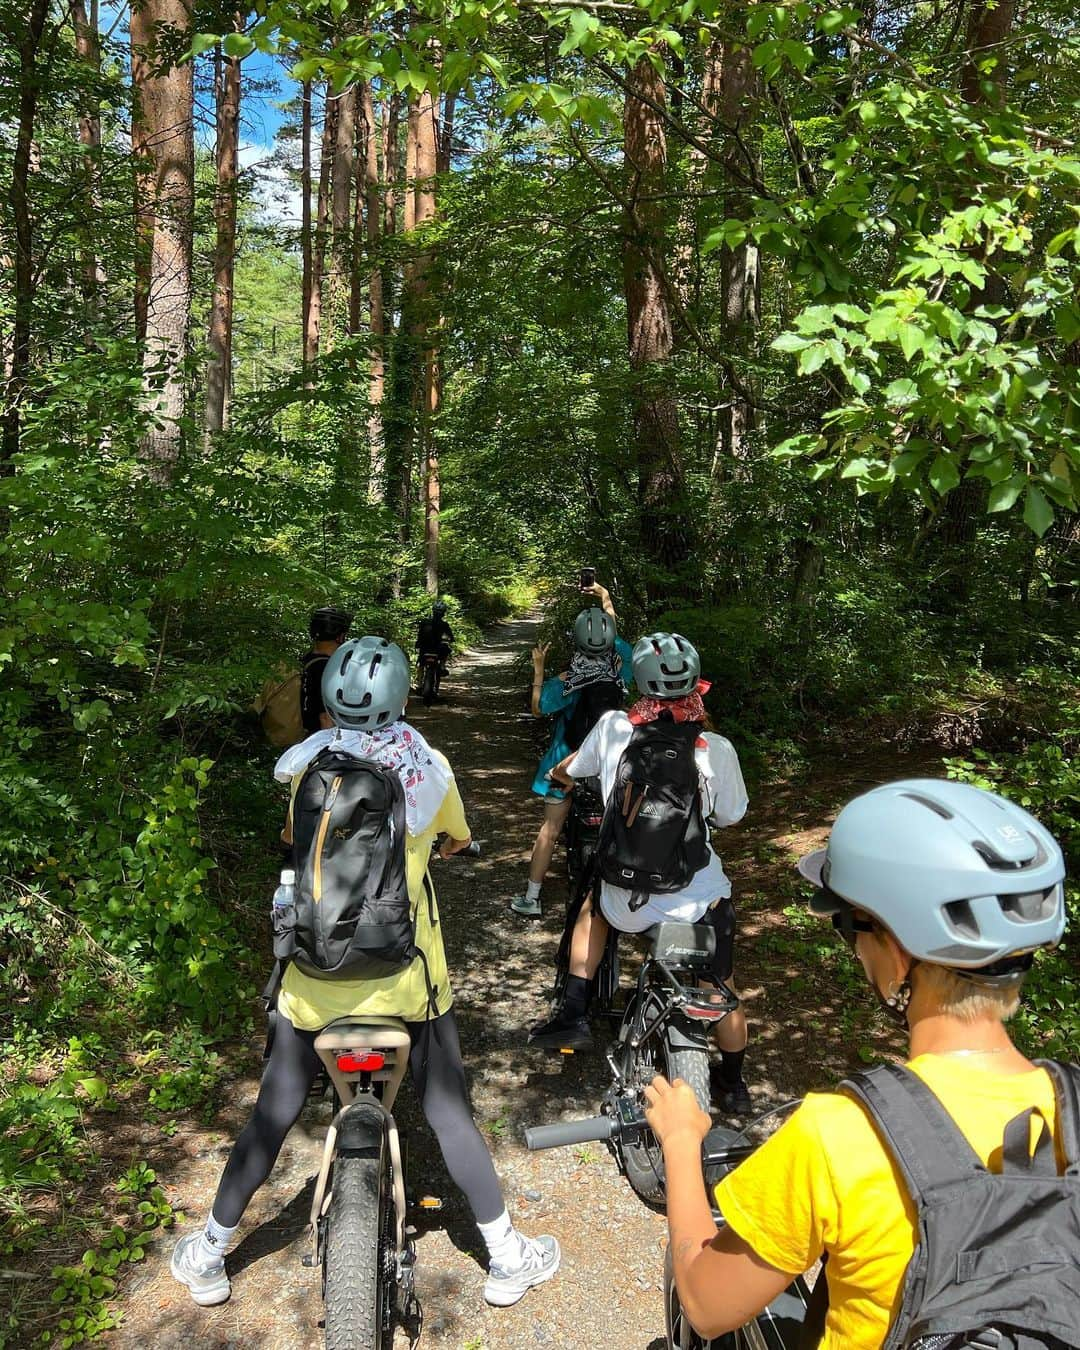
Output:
[{"xmin": 111, "ymin": 618, "xmax": 927, "ymax": 1350}]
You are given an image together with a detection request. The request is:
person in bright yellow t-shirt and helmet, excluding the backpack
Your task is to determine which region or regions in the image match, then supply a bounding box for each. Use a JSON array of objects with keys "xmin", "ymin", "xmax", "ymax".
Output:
[{"xmin": 645, "ymin": 779, "xmax": 1065, "ymax": 1350}]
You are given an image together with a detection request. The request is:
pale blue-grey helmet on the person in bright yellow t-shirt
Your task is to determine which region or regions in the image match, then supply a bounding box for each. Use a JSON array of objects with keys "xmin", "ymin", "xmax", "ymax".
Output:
[{"xmin": 799, "ymin": 778, "xmax": 1065, "ymax": 981}]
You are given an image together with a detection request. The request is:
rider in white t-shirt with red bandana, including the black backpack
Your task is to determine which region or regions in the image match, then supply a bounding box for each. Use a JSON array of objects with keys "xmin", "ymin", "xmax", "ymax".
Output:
[{"xmin": 529, "ymin": 633, "xmax": 751, "ymax": 1114}]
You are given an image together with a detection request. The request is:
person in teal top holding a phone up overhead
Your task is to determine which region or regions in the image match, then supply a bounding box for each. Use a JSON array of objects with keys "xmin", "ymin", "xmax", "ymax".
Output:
[{"xmin": 510, "ymin": 582, "xmax": 630, "ymax": 919}]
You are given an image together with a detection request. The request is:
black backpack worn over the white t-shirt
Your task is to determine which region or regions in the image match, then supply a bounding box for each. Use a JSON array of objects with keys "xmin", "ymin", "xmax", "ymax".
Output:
[{"xmin": 598, "ymin": 718, "xmax": 709, "ymax": 910}]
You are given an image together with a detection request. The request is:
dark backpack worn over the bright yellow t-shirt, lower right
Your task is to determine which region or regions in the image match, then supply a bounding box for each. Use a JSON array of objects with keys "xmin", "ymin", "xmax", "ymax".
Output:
[{"xmin": 842, "ymin": 1061, "xmax": 1080, "ymax": 1350}]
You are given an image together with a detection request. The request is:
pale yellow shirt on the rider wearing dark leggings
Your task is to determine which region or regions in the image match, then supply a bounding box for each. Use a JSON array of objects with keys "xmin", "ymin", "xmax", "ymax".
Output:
[{"xmin": 278, "ymin": 752, "xmax": 468, "ymax": 1031}]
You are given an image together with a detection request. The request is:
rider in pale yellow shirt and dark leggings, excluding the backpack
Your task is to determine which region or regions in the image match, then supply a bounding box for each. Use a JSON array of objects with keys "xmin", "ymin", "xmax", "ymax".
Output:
[{"xmin": 171, "ymin": 637, "xmax": 560, "ymax": 1307}]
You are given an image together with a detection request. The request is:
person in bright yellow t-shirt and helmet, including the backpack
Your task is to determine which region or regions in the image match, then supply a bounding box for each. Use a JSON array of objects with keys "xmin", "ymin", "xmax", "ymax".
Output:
[{"xmin": 645, "ymin": 779, "xmax": 1080, "ymax": 1350}]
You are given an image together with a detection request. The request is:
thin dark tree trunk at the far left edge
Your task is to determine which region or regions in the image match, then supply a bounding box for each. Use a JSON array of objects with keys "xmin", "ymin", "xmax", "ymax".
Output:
[{"xmin": 0, "ymin": 0, "xmax": 49, "ymax": 474}]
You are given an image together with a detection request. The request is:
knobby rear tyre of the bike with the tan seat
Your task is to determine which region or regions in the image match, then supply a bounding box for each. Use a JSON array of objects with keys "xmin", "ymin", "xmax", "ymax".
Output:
[{"xmin": 324, "ymin": 1135, "xmax": 396, "ymax": 1350}]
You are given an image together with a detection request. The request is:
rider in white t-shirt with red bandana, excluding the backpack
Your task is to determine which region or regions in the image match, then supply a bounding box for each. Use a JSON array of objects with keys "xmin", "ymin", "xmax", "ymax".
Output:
[{"xmin": 529, "ymin": 633, "xmax": 752, "ymax": 1115}]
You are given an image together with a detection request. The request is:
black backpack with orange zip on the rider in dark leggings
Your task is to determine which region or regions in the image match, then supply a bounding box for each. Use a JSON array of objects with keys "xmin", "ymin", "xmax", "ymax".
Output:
[{"xmin": 274, "ymin": 749, "xmax": 419, "ymax": 980}]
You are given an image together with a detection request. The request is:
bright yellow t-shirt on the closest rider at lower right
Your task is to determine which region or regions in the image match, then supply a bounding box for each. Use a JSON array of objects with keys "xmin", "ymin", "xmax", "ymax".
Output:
[{"xmin": 716, "ymin": 1054, "xmax": 1056, "ymax": 1350}]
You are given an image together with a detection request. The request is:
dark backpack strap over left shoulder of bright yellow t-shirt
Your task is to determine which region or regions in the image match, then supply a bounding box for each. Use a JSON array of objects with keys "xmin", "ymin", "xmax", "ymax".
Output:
[{"xmin": 841, "ymin": 1064, "xmax": 987, "ymax": 1204}]
